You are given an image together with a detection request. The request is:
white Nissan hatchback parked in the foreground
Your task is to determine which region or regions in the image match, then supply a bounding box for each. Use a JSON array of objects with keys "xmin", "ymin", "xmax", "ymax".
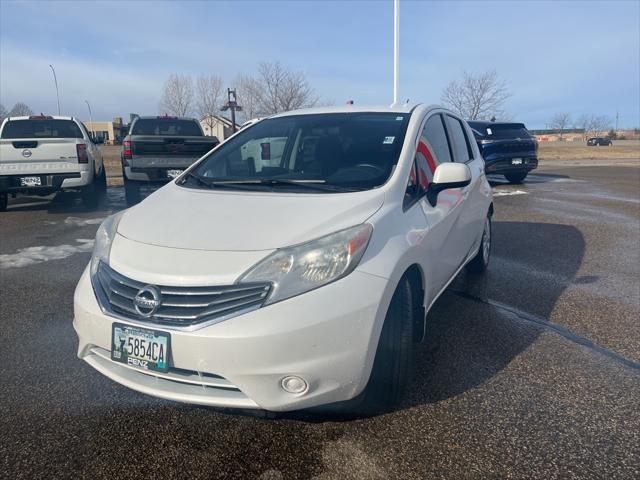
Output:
[{"xmin": 74, "ymin": 105, "xmax": 493, "ymax": 411}]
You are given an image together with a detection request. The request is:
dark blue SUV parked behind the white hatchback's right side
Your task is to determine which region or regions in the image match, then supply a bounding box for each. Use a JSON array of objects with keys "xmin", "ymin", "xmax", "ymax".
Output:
[{"xmin": 467, "ymin": 120, "xmax": 538, "ymax": 183}]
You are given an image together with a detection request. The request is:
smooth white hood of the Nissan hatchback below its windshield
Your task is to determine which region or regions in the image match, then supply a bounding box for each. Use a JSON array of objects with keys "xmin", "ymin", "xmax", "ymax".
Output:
[{"xmin": 118, "ymin": 183, "xmax": 384, "ymax": 251}]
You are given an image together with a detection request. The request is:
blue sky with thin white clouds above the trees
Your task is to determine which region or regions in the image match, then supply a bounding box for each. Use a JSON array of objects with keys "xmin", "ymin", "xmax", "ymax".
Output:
[{"xmin": 0, "ymin": 0, "xmax": 640, "ymax": 128}]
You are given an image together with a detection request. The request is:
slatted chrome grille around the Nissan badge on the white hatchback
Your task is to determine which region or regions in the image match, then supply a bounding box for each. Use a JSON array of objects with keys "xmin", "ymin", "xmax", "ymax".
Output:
[{"xmin": 92, "ymin": 263, "xmax": 271, "ymax": 327}]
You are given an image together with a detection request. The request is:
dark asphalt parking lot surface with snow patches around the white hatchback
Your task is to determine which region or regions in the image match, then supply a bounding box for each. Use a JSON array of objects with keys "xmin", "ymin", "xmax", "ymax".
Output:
[{"xmin": 0, "ymin": 158, "xmax": 640, "ymax": 479}]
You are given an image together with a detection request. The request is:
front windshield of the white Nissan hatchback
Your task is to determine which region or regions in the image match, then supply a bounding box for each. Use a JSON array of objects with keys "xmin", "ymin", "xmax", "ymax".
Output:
[{"xmin": 183, "ymin": 113, "xmax": 410, "ymax": 192}]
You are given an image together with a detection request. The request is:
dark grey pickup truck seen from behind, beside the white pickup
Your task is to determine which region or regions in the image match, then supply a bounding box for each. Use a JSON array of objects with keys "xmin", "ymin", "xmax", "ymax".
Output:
[{"xmin": 121, "ymin": 116, "xmax": 220, "ymax": 205}]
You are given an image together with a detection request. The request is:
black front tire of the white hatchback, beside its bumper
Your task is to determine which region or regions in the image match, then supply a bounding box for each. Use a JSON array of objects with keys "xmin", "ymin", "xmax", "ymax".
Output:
[{"xmin": 360, "ymin": 277, "xmax": 415, "ymax": 414}]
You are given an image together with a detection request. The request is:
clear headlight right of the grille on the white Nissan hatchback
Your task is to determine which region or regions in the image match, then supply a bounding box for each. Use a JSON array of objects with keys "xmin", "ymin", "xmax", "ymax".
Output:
[{"xmin": 240, "ymin": 223, "xmax": 373, "ymax": 305}]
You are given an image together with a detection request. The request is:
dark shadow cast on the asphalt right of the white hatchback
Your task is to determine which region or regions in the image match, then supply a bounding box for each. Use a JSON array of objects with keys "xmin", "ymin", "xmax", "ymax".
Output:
[{"xmin": 403, "ymin": 222, "xmax": 585, "ymax": 408}]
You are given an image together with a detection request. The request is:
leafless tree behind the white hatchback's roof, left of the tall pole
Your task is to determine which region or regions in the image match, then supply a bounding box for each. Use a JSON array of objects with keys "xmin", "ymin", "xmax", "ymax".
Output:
[{"xmin": 238, "ymin": 62, "xmax": 318, "ymax": 118}]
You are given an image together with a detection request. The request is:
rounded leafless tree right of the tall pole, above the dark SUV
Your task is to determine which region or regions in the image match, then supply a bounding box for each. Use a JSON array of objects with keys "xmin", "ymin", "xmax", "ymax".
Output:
[{"xmin": 440, "ymin": 70, "xmax": 511, "ymax": 120}]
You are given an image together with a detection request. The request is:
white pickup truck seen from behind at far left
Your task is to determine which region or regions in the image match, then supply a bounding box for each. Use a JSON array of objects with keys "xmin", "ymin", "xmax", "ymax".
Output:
[{"xmin": 0, "ymin": 115, "xmax": 107, "ymax": 211}]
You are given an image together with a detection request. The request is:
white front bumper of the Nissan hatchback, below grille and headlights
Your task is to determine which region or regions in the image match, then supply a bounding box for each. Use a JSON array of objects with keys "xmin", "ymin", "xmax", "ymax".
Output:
[{"xmin": 73, "ymin": 268, "xmax": 392, "ymax": 411}]
